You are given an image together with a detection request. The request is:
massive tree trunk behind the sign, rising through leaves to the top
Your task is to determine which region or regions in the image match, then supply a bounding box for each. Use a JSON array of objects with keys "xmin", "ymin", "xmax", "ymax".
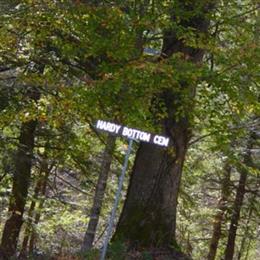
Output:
[{"xmin": 114, "ymin": 1, "xmax": 213, "ymax": 251}]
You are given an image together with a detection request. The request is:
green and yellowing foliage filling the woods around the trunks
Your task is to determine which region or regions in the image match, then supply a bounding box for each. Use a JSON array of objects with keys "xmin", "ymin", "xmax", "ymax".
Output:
[{"xmin": 0, "ymin": 0, "xmax": 260, "ymax": 259}]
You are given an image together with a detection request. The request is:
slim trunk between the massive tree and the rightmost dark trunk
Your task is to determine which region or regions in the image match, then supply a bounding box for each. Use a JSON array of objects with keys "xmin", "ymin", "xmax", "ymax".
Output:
[{"xmin": 207, "ymin": 162, "xmax": 231, "ymax": 260}]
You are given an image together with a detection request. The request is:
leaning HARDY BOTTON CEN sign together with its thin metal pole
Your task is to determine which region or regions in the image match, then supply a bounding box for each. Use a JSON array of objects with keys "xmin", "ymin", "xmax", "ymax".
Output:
[{"xmin": 96, "ymin": 120, "xmax": 169, "ymax": 260}]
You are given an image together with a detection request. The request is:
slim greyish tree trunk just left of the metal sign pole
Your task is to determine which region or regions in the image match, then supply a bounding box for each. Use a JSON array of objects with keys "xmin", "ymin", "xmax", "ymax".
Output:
[{"xmin": 81, "ymin": 135, "xmax": 116, "ymax": 252}]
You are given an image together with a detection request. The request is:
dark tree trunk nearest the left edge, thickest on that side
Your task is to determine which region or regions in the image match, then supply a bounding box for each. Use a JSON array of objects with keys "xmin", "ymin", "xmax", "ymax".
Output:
[{"xmin": 1, "ymin": 90, "xmax": 39, "ymax": 259}]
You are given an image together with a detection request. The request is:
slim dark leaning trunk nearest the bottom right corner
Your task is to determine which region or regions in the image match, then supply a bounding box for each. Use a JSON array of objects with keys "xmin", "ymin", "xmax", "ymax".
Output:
[{"xmin": 224, "ymin": 133, "xmax": 255, "ymax": 260}]
